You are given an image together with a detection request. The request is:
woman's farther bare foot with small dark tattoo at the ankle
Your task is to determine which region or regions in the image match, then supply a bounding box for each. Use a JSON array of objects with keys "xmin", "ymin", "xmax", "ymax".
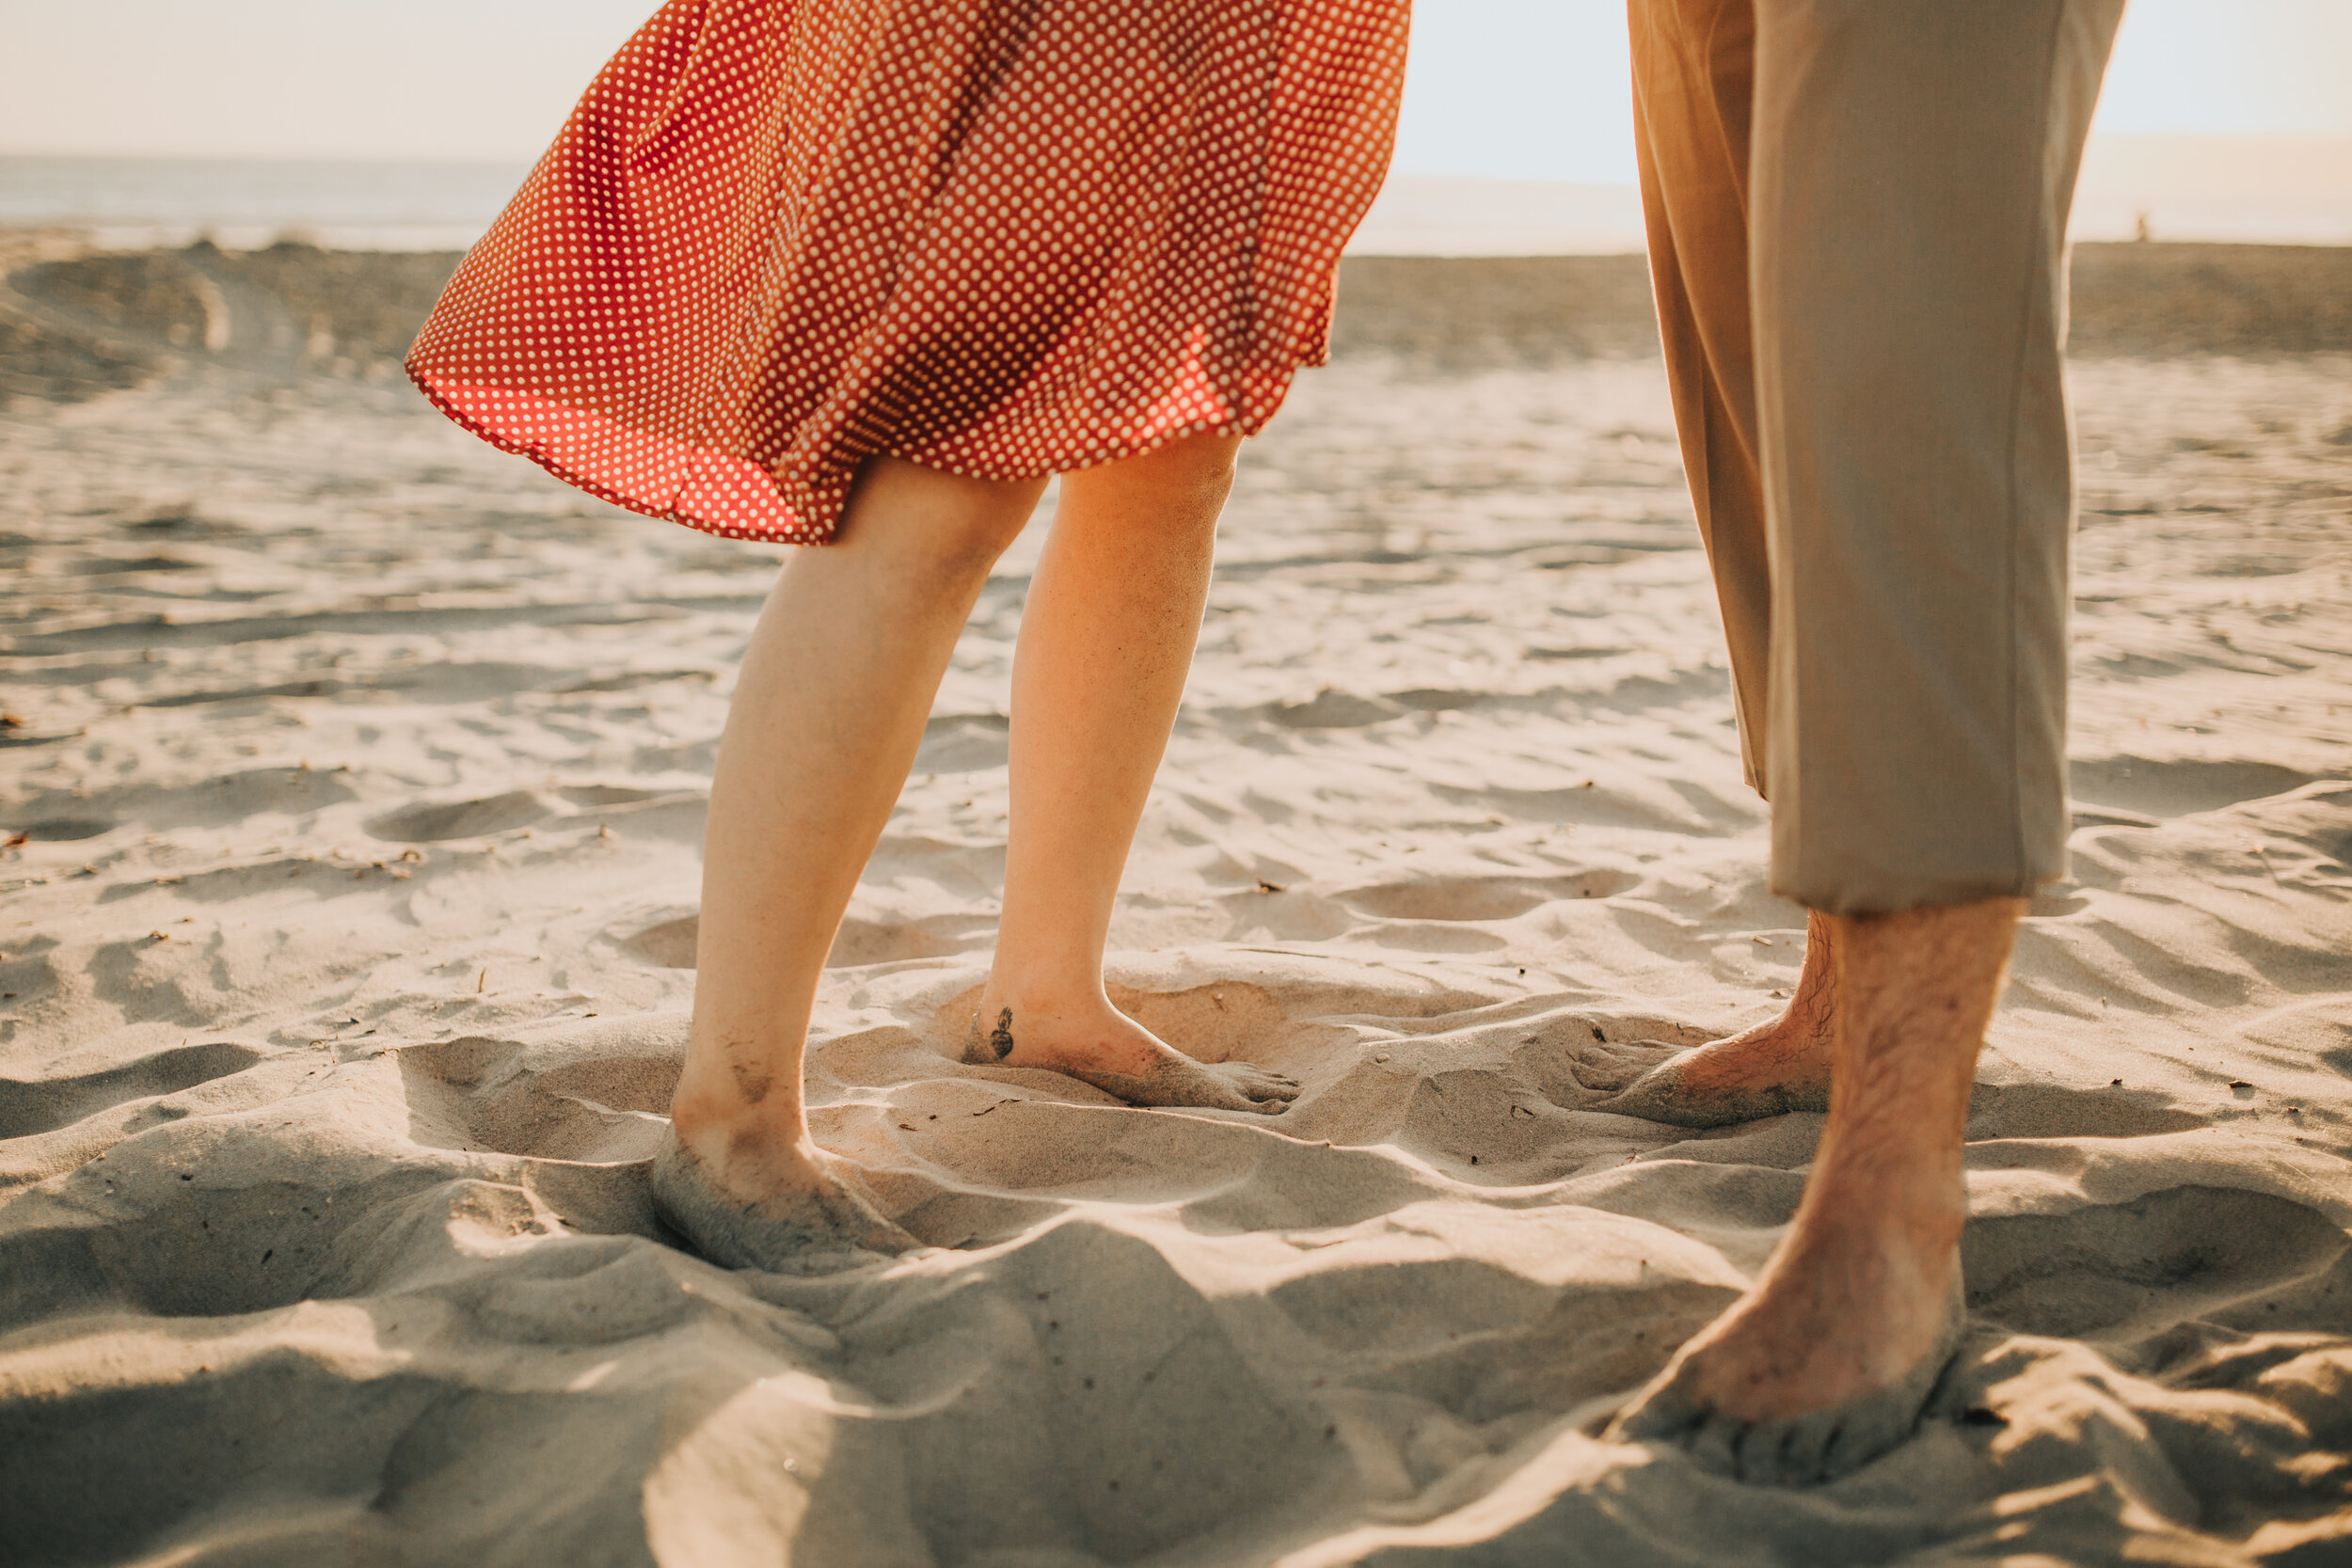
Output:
[{"xmin": 964, "ymin": 997, "xmax": 1298, "ymax": 1117}]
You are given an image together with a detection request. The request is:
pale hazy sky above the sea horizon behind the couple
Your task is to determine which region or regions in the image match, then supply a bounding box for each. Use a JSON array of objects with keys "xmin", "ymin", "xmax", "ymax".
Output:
[{"xmin": 0, "ymin": 0, "xmax": 2352, "ymax": 183}]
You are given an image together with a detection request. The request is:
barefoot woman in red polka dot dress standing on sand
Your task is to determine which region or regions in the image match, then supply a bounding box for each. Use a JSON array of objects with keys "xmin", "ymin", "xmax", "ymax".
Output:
[{"xmin": 409, "ymin": 0, "xmax": 1406, "ymax": 1267}]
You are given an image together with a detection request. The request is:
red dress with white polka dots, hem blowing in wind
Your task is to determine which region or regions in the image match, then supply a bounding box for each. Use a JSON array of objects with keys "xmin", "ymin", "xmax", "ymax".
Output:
[{"xmin": 409, "ymin": 0, "xmax": 1406, "ymax": 543}]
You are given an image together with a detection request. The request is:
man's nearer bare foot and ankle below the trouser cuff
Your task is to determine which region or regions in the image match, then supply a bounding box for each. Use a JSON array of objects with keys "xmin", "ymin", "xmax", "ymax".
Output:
[{"xmin": 1612, "ymin": 898, "xmax": 2021, "ymax": 1483}]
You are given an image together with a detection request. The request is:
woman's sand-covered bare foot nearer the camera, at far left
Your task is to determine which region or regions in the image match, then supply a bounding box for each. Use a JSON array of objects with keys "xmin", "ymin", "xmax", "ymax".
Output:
[{"xmin": 652, "ymin": 1129, "xmax": 922, "ymax": 1275}]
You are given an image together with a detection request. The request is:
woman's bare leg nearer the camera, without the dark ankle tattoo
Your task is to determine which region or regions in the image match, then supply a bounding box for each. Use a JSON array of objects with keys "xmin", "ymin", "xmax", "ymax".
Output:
[{"xmin": 657, "ymin": 458, "xmax": 1044, "ymax": 1251}]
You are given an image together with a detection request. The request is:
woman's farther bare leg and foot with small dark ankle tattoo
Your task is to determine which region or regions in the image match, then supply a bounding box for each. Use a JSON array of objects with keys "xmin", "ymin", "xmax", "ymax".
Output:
[{"xmin": 967, "ymin": 437, "xmax": 1298, "ymax": 1112}]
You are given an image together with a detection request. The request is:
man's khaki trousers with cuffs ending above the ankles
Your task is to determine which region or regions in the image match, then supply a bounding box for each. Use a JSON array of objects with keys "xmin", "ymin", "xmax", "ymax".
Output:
[{"xmin": 1630, "ymin": 0, "xmax": 2124, "ymax": 914}]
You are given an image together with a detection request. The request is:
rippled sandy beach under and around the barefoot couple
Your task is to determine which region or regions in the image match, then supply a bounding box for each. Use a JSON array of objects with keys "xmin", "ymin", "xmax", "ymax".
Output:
[{"xmin": 0, "ymin": 232, "xmax": 2352, "ymax": 1568}]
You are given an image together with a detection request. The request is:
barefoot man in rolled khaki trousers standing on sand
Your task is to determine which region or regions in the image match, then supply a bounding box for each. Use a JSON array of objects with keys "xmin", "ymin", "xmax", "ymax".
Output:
[{"xmin": 1581, "ymin": 0, "xmax": 2122, "ymax": 1481}]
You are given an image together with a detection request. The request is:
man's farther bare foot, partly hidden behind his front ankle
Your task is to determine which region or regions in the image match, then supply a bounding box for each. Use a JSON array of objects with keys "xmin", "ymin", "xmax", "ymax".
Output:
[{"xmin": 1569, "ymin": 914, "xmax": 1837, "ymax": 1126}]
